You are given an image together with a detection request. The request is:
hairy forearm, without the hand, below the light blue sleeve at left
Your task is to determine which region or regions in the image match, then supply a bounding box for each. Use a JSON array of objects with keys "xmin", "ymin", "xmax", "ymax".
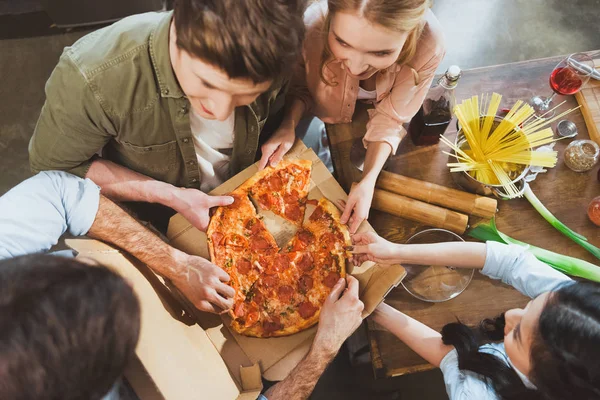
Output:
[{"xmin": 88, "ymin": 196, "xmax": 187, "ymax": 281}]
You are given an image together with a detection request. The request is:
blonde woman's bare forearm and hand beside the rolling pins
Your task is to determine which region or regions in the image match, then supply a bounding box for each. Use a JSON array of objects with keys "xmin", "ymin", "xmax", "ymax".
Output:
[{"xmin": 341, "ymin": 142, "xmax": 392, "ymax": 233}]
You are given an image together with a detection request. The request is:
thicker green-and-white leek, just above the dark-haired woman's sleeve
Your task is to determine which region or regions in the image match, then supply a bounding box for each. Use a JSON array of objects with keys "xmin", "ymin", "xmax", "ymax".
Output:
[{"xmin": 469, "ymin": 219, "xmax": 600, "ymax": 282}]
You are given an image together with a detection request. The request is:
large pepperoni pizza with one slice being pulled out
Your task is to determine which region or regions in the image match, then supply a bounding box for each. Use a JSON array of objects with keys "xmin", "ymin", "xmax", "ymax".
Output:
[{"xmin": 207, "ymin": 160, "xmax": 351, "ymax": 337}]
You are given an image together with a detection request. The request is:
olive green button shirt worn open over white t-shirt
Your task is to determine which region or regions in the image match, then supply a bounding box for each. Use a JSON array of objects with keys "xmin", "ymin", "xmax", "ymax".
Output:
[{"xmin": 29, "ymin": 12, "xmax": 284, "ymax": 188}]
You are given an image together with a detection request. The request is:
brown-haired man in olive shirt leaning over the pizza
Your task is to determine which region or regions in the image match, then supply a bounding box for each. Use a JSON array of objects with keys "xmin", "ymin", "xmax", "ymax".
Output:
[{"xmin": 29, "ymin": 0, "xmax": 304, "ymax": 316}]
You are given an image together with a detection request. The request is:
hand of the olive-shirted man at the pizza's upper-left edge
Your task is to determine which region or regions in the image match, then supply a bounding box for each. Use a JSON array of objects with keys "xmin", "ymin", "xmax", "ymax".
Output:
[{"xmin": 170, "ymin": 188, "xmax": 233, "ymax": 232}]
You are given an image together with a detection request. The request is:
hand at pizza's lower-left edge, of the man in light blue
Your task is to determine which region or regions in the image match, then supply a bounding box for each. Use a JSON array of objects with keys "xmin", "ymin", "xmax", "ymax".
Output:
[{"xmin": 172, "ymin": 251, "xmax": 235, "ymax": 313}]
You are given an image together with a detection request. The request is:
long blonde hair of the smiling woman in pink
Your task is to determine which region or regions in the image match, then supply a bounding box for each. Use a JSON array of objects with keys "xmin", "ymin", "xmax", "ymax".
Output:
[{"xmin": 320, "ymin": 0, "xmax": 432, "ymax": 85}]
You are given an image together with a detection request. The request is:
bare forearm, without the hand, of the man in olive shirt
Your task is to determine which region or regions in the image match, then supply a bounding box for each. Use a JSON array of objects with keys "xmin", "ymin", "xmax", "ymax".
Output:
[{"xmin": 86, "ymin": 159, "xmax": 178, "ymax": 208}]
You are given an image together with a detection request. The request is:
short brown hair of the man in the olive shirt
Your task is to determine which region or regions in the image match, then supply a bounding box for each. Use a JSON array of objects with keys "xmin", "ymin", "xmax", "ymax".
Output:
[{"xmin": 174, "ymin": 0, "xmax": 306, "ymax": 83}]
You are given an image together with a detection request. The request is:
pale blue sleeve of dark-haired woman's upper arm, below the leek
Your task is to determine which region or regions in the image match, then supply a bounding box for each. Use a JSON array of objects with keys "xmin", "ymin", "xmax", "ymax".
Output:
[{"xmin": 481, "ymin": 241, "xmax": 573, "ymax": 298}]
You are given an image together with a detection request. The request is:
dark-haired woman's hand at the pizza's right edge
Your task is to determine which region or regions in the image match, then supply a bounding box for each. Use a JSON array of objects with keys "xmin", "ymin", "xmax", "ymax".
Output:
[{"xmin": 350, "ymin": 232, "xmax": 402, "ymax": 265}]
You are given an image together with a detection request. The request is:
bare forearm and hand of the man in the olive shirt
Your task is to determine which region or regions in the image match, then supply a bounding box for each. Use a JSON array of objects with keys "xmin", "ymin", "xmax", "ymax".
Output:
[{"xmin": 86, "ymin": 159, "xmax": 233, "ymax": 231}]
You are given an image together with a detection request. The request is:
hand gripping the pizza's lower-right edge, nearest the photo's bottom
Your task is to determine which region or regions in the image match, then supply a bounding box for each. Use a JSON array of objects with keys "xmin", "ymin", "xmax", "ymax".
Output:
[{"xmin": 313, "ymin": 275, "xmax": 364, "ymax": 354}]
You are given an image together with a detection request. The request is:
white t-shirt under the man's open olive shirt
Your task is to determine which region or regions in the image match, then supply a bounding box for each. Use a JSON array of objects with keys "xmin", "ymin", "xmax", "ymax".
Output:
[{"xmin": 190, "ymin": 110, "xmax": 235, "ymax": 193}]
